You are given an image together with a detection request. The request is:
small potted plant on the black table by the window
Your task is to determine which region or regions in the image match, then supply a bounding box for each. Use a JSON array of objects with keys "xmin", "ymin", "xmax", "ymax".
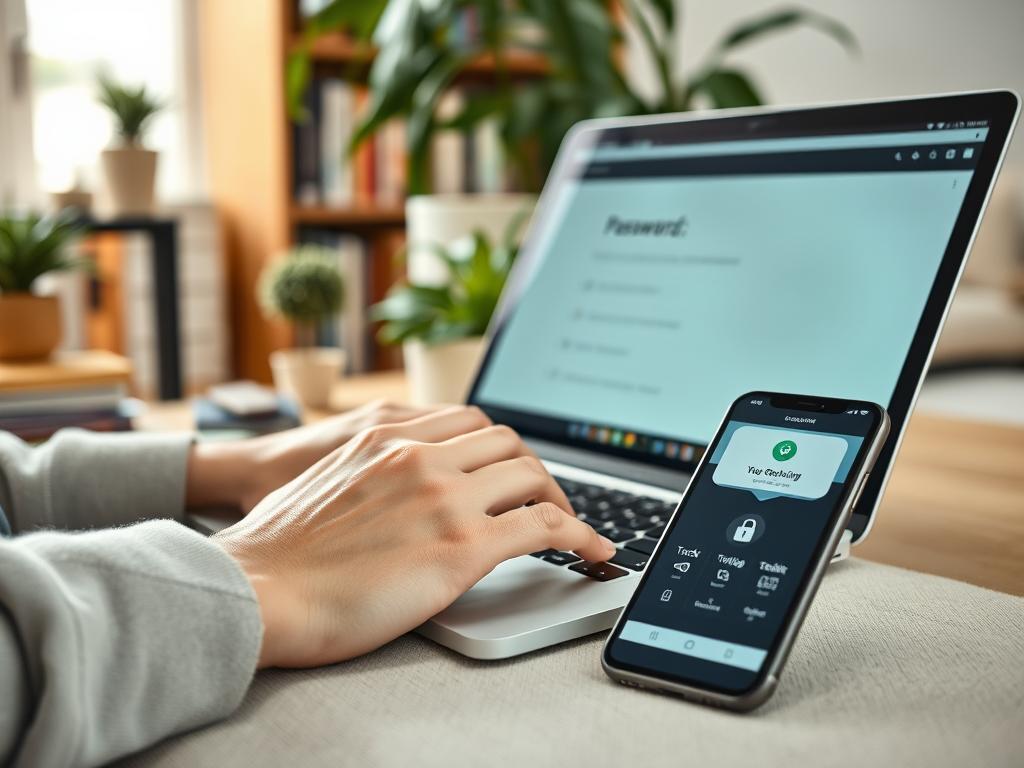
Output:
[{"xmin": 98, "ymin": 76, "xmax": 164, "ymax": 216}]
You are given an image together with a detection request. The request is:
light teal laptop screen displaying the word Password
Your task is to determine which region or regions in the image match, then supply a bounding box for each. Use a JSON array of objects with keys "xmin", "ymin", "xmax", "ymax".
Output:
[{"xmin": 476, "ymin": 127, "xmax": 988, "ymax": 450}]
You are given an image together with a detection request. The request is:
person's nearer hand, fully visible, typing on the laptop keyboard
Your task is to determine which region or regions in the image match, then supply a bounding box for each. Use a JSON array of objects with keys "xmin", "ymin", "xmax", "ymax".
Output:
[{"xmin": 213, "ymin": 407, "xmax": 614, "ymax": 667}]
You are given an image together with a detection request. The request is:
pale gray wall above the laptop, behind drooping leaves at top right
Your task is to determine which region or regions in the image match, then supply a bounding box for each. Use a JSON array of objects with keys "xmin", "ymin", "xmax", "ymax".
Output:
[{"xmin": 629, "ymin": 0, "xmax": 1024, "ymax": 170}]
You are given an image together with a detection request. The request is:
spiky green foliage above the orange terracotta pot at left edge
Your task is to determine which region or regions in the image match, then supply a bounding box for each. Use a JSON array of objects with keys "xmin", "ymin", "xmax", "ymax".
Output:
[{"xmin": 0, "ymin": 211, "xmax": 92, "ymax": 292}]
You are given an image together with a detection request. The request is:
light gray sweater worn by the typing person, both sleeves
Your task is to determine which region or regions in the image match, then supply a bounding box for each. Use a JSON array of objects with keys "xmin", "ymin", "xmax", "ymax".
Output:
[{"xmin": 0, "ymin": 430, "xmax": 262, "ymax": 767}]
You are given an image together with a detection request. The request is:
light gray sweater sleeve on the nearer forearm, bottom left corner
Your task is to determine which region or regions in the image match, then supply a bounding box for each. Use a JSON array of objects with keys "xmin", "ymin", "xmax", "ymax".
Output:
[{"xmin": 0, "ymin": 521, "xmax": 262, "ymax": 766}]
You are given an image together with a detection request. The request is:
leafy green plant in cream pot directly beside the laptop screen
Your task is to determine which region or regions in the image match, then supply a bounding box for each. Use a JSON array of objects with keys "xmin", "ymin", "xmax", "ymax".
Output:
[{"xmin": 370, "ymin": 220, "xmax": 519, "ymax": 404}]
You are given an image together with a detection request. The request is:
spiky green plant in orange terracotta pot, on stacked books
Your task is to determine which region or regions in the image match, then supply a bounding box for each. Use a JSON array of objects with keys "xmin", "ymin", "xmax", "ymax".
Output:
[{"xmin": 0, "ymin": 213, "xmax": 90, "ymax": 360}]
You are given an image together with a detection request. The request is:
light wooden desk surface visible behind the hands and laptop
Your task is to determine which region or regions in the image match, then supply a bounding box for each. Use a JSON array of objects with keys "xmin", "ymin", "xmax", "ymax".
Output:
[{"xmin": 142, "ymin": 373, "xmax": 1024, "ymax": 596}]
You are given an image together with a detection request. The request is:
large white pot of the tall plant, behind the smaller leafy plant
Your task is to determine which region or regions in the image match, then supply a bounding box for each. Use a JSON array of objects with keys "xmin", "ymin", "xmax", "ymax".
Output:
[{"xmin": 406, "ymin": 195, "xmax": 537, "ymax": 286}]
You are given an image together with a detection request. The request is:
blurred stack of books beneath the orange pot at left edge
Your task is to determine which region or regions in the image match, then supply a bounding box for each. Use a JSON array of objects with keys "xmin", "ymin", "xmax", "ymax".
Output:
[{"xmin": 0, "ymin": 350, "xmax": 131, "ymax": 442}]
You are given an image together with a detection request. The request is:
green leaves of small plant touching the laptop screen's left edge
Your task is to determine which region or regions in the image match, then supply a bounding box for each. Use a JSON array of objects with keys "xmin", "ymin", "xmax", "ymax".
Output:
[{"xmin": 370, "ymin": 219, "xmax": 521, "ymax": 344}]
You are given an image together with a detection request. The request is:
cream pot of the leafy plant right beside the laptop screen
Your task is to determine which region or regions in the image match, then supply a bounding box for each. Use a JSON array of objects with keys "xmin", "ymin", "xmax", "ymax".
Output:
[{"xmin": 401, "ymin": 336, "xmax": 483, "ymax": 406}]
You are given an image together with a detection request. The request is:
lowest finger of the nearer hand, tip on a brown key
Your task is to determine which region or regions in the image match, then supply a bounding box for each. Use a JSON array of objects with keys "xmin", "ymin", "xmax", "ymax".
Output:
[{"xmin": 486, "ymin": 504, "xmax": 615, "ymax": 562}]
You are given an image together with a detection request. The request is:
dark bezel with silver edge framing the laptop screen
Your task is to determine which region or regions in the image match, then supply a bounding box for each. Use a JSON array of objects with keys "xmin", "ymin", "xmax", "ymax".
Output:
[{"xmin": 467, "ymin": 90, "xmax": 1020, "ymax": 544}]
